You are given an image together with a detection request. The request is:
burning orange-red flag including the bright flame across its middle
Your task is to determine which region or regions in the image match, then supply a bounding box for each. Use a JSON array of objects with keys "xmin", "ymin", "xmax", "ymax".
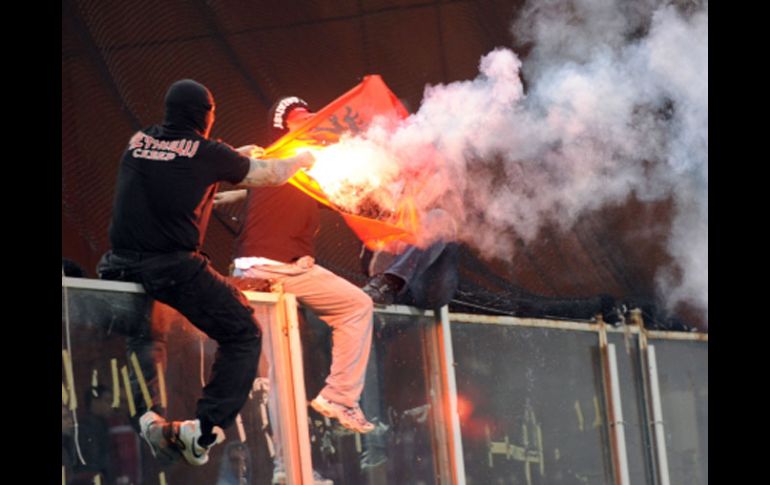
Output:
[{"xmin": 265, "ymin": 75, "xmax": 424, "ymax": 249}]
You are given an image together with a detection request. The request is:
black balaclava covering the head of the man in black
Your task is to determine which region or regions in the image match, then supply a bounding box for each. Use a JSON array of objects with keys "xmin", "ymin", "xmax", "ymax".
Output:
[{"xmin": 163, "ymin": 79, "xmax": 214, "ymax": 136}]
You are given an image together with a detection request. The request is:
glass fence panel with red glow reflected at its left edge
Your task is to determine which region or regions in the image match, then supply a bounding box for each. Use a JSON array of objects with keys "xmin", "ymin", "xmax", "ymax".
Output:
[{"xmin": 450, "ymin": 322, "xmax": 613, "ymax": 485}]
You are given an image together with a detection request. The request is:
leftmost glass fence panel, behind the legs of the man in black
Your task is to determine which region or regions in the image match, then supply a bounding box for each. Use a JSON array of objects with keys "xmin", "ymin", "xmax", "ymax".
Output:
[{"xmin": 62, "ymin": 284, "xmax": 274, "ymax": 485}]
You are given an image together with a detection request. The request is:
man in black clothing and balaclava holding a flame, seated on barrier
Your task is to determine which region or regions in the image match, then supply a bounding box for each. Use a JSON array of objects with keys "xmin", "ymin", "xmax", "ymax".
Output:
[{"xmin": 97, "ymin": 79, "xmax": 314, "ymax": 465}]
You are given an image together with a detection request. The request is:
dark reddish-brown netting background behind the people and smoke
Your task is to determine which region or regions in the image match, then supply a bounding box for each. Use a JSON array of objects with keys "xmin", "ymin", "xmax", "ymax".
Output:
[{"xmin": 61, "ymin": 0, "xmax": 707, "ymax": 328}]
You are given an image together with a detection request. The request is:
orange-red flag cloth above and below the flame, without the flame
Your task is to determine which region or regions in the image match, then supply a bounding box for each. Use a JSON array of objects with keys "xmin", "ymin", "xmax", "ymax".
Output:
[{"xmin": 265, "ymin": 75, "xmax": 417, "ymax": 249}]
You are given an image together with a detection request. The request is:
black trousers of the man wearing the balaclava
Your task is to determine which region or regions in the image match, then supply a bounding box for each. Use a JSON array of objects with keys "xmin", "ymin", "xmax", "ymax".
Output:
[{"xmin": 97, "ymin": 250, "xmax": 262, "ymax": 429}]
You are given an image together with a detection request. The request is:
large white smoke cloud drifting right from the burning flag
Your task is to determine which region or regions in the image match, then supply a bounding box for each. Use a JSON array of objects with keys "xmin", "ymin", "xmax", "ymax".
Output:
[{"xmin": 320, "ymin": 0, "xmax": 708, "ymax": 326}]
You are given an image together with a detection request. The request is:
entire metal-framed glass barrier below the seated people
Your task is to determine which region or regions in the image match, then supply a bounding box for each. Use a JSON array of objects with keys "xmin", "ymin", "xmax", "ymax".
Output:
[{"xmin": 62, "ymin": 278, "xmax": 708, "ymax": 485}]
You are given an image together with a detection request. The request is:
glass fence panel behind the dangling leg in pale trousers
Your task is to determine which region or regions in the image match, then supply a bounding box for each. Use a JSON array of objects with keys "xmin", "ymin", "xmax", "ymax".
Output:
[{"xmin": 300, "ymin": 312, "xmax": 441, "ymax": 485}]
